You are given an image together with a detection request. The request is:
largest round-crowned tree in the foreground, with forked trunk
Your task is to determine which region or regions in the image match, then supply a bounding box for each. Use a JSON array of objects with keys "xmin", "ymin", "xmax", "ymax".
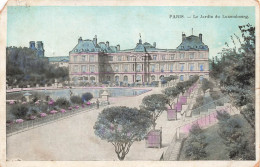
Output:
[{"xmin": 94, "ymin": 106, "xmax": 151, "ymax": 160}]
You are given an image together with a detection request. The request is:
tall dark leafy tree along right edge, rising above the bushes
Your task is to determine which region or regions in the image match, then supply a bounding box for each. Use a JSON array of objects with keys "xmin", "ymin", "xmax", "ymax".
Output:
[{"xmin": 210, "ymin": 24, "xmax": 255, "ymax": 127}]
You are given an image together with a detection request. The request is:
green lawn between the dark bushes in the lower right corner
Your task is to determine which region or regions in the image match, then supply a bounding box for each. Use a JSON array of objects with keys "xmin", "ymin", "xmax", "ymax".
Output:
[{"xmin": 179, "ymin": 114, "xmax": 255, "ymax": 160}]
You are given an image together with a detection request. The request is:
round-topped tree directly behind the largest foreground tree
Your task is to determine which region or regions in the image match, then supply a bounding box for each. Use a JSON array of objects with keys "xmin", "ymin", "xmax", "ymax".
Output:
[{"xmin": 140, "ymin": 94, "xmax": 168, "ymax": 130}]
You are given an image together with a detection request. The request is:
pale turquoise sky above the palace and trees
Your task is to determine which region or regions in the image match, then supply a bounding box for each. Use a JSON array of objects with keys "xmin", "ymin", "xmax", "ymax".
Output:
[{"xmin": 7, "ymin": 6, "xmax": 255, "ymax": 57}]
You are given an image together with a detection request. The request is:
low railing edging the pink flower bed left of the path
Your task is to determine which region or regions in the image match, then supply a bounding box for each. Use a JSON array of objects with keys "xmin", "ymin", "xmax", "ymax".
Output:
[{"xmin": 6, "ymin": 104, "xmax": 107, "ymax": 137}]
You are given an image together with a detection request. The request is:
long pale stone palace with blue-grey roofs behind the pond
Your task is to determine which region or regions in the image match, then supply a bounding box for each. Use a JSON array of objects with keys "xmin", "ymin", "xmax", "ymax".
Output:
[{"xmin": 69, "ymin": 34, "xmax": 209, "ymax": 85}]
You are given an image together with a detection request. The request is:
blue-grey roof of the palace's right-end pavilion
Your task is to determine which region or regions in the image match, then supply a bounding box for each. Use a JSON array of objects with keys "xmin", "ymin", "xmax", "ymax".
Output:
[{"xmin": 177, "ymin": 35, "xmax": 209, "ymax": 50}]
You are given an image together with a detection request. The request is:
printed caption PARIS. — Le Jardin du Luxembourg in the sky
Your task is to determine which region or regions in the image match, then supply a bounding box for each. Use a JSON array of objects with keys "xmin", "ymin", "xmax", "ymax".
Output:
[{"xmin": 169, "ymin": 14, "xmax": 249, "ymax": 19}]
